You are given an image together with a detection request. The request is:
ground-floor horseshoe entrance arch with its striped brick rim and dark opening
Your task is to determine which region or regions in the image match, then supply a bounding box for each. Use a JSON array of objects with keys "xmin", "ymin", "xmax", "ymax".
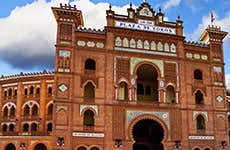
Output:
[{"xmin": 128, "ymin": 115, "xmax": 168, "ymax": 150}]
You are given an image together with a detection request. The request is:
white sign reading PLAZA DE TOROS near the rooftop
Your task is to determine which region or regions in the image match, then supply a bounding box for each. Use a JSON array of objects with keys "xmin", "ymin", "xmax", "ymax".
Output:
[{"xmin": 115, "ymin": 21, "xmax": 176, "ymax": 34}]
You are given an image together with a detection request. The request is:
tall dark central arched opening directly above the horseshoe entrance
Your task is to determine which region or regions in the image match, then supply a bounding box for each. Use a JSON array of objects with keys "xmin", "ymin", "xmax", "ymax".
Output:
[{"xmin": 137, "ymin": 64, "xmax": 158, "ymax": 101}]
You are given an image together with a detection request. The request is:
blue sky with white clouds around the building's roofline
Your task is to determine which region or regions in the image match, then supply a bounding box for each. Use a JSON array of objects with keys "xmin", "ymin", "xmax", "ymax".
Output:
[{"xmin": 0, "ymin": 0, "xmax": 230, "ymax": 88}]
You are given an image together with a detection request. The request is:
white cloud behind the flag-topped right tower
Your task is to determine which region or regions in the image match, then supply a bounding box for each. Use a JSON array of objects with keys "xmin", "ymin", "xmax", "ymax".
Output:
[{"xmin": 191, "ymin": 11, "xmax": 230, "ymax": 41}]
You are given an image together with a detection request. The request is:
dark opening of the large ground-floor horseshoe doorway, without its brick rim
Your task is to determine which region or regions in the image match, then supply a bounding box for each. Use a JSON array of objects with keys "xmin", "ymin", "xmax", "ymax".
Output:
[{"xmin": 133, "ymin": 119, "xmax": 164, "ymax": 150}]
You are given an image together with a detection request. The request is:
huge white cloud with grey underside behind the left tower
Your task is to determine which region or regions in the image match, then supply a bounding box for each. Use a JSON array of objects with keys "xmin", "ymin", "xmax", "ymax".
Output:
[{"xmin": 0, "ymin": 0, "xmax": 131, "ymax": 69}]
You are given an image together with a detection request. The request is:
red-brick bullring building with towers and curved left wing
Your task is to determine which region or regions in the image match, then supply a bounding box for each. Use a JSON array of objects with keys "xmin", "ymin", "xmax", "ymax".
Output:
[{"xmin": 0, "ymin": 2, "xmax": 230, "ymax": 150}]
